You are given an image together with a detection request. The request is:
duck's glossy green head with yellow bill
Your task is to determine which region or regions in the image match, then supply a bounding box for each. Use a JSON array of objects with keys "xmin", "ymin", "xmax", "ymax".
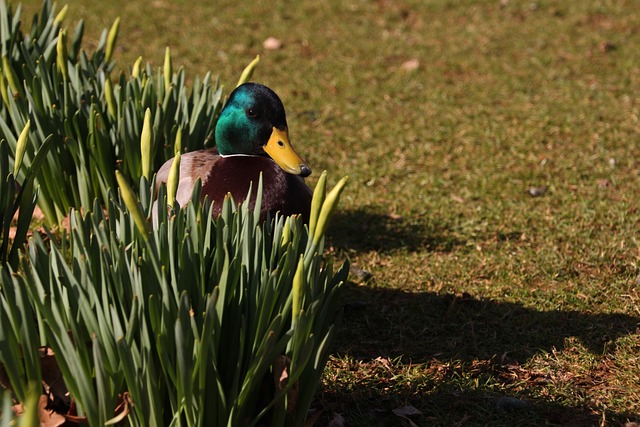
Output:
[{"xmin": 216, "ymin": 83, "xmax": 311, "ymax": 177}]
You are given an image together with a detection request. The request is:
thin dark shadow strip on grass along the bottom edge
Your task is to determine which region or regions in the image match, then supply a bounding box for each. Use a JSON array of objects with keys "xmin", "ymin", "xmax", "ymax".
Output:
[{"xmin": 318, "ymin": 388, "xmax": 640, "ymax": 427}]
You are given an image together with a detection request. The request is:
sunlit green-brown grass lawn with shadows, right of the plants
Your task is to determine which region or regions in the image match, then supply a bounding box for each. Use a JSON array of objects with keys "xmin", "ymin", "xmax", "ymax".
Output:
[{"xmin": 15, "ymin": 0, "xmax": 640, "ymax": 426}]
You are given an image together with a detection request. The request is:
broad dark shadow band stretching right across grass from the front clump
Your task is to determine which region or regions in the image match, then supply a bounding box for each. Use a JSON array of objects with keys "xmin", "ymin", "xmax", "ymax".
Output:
[{"xmin": 337, "ymin": 285, "xmax": 640, "ymax": 363}]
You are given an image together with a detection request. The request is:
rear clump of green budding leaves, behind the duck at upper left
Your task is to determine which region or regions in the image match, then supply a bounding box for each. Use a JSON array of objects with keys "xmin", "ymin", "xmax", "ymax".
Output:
[{"xmin": 0, "ymin": 0, "xmax": 222, "ymax": 225}]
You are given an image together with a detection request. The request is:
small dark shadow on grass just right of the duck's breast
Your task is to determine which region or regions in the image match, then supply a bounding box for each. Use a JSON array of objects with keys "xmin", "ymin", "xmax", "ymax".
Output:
[{"xmin": 327, "ymin": 208, "xmax": 462, "ymax": 253}]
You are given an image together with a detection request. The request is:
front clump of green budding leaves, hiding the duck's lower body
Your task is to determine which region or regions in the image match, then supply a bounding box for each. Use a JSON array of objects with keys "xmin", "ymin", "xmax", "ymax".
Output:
[{"xmin": 0, "ymin": 173, "xmax": 348, "ymax": 426}]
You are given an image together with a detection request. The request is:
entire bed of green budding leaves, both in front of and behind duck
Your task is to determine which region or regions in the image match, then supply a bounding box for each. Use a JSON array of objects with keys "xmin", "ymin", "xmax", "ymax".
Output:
[{"xmin": 0, "ymin": 0, "xmax": 348, "ymax": 426}]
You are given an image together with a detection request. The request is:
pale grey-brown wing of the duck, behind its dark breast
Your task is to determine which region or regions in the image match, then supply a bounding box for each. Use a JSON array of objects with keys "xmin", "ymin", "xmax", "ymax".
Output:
[{"xmin": 156, "ymin": 148, "xmax": 220, "ymax": 206}]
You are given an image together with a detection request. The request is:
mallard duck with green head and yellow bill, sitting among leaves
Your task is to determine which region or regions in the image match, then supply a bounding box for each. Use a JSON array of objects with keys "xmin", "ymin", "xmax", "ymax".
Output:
[{"xmin": 156, "ymin": 83, "xmax": 312, "ymax": 221}]
